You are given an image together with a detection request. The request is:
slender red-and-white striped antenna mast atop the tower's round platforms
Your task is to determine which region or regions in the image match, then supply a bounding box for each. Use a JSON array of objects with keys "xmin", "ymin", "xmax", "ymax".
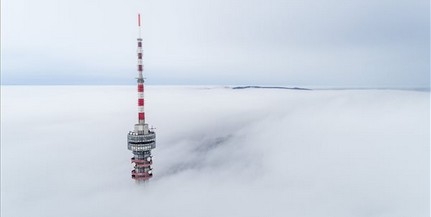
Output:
[{"xmin": 137, "ymin": 14, "xmax": 145, "ymax": 124}]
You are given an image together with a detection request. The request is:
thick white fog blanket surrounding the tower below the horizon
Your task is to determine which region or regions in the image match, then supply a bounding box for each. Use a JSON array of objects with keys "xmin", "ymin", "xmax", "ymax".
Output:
[{"xmin": 1, "ymin": 86, "xmax": 430, "ymax": 217}]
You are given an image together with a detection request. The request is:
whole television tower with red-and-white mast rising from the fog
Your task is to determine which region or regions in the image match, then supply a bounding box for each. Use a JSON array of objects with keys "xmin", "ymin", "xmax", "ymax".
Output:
[{"xmin": 127, "ymin": 14, "xmax": 156, "ymax": 183}]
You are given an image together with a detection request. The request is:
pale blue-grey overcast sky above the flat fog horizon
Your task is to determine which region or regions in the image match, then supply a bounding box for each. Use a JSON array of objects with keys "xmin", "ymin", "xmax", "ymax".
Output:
[{"xmin": 1, "ymin": 0, "xmax": 430, "ymax": 88}]
